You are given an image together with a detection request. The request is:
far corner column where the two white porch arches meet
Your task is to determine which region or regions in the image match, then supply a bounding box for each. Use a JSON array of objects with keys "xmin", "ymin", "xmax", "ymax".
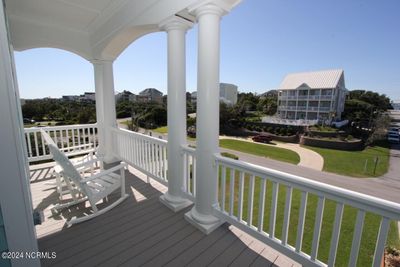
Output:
[{"xmin": 91, "ymin": 60, "xmax": 117, "ymax": 164}]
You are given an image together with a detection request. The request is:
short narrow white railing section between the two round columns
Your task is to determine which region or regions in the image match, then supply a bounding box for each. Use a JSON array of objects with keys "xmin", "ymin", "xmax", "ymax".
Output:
[{"xmin": 182, "ymin": 146, "xmax": 196, "ymax": 201}]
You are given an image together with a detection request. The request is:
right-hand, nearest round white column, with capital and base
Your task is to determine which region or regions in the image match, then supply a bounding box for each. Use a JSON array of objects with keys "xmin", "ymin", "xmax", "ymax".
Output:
[{"xmin": 185, "ymin": 4, "xmax": 224, "ymax": 234}]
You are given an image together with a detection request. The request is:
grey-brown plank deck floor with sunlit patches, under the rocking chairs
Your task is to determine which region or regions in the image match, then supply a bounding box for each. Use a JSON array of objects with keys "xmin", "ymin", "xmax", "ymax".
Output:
[{"xmin": 31, "ymin": 165, "xmax": 299, "ymax": 266}]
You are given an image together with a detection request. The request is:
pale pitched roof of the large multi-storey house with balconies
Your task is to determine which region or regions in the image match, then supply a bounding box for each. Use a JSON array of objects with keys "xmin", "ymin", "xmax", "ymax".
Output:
[{"xmin": 279, "ymin": 69, "xmax": 344, "ymax": 90}]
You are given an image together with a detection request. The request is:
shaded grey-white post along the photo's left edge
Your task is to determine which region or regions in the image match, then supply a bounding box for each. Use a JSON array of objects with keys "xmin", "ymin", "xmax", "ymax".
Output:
[{"xmin": 0, "ymin": 3, "xmax": 40, "ymax": 267}]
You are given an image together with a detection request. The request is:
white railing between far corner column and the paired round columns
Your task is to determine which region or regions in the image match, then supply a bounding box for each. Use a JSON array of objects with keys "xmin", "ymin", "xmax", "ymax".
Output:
[{"xmin": 110, "ymin": 128, "xmax": 168, "ymax": 185}]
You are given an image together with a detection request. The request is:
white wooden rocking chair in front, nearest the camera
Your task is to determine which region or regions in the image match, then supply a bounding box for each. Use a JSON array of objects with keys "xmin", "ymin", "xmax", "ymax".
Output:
[{"xmin": 42, "ymin": 131, "xmax": 128, "ymax": 225}]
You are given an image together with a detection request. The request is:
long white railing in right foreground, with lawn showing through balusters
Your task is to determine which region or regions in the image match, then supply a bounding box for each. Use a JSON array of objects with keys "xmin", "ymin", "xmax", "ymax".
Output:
[{"xmin": 214, "ymin": 154, "xmax": 400, "ymax": 266}]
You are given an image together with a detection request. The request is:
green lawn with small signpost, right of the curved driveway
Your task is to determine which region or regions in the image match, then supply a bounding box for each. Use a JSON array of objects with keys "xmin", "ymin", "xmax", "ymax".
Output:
[{"xmin": 305, "ymin": 145, "xmax": 389, "ymax": 177}]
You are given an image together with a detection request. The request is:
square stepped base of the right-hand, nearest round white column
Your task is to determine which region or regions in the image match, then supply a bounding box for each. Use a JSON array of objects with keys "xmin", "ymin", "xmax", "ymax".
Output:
[{"xmin": 185, "ymin": 207, "xmax": 224, "ymax": 235}]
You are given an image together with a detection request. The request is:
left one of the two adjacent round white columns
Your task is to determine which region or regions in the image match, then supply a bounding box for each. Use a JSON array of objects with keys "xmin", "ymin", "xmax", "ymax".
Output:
[{"xmin": 160, "ymin": 16, "xmax": 192, "ymax": 212}]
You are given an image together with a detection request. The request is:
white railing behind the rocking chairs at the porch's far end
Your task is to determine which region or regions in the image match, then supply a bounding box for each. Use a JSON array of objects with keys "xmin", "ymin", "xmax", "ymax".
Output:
[{"xmin": 24, "ymin": 124, "xmax": 98, "ymax": 162}]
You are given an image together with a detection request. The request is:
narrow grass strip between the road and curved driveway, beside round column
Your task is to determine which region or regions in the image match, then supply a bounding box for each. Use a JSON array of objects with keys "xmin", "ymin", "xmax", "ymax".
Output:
[{"xmin": 219, "ymin": 139, "xmax": 300, "ymax": 164}]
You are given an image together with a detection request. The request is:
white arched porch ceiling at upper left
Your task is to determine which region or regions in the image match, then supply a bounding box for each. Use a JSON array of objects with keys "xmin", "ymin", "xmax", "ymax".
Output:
[{"xmin": 6, "ymin": 0, "xmax": 202, "ymax": 60}]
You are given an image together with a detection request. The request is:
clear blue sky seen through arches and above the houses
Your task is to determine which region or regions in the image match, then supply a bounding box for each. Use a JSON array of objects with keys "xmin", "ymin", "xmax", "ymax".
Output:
[{"xmin": 15, "ymin": 0, "xmax": 400, "ymax": 99}]
